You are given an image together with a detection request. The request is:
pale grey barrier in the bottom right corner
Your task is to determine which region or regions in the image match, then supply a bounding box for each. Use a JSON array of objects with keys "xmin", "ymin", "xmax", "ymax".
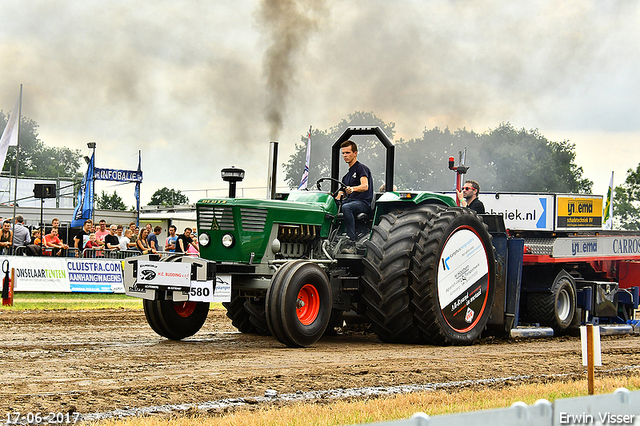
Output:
[{"xmin": 352, "ymin": 388, "xmax": 640, "ymax": 426}]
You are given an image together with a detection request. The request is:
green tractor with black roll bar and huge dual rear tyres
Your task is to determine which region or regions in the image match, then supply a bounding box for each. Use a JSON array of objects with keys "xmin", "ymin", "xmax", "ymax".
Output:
[{"xmin": 130, "ymin": 127, "xmax": 496, "ymax": 347}]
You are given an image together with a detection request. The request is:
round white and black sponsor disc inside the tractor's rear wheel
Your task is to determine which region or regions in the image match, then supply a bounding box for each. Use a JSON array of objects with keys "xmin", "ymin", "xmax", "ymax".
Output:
[{"xmin": 438, "ymin": 229, "xmax": 489, "ymax": 331}]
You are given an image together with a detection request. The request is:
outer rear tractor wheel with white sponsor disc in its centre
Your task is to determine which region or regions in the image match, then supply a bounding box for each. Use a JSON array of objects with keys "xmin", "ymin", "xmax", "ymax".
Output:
[{"xmin": 411, "ymin": 206, "xmax": 496, "ymax": 345}]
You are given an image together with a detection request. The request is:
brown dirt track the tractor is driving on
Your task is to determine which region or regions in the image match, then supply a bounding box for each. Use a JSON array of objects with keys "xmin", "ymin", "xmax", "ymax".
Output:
[{"xmin": 0, "ymin": 310, "xmax": 640, "ymax": 418}]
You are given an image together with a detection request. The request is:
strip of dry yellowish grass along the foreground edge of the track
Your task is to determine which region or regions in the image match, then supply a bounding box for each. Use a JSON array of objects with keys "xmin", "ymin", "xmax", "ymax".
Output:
[{"xmin": 89, "ymin": 372, "xmax": 640, "ymax": 426}]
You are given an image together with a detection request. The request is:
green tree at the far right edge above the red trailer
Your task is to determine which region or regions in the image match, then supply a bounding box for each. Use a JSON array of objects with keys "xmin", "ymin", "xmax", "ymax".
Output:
[{"xmin": 613, "ymin": 164, "xmax": 640, "ymax": 231}]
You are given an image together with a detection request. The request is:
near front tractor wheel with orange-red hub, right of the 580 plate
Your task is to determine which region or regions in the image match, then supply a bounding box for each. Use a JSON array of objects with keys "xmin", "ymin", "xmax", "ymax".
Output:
[{"xmin": 266, "ymin": 260, "xmax": 332, "ymax": 347}]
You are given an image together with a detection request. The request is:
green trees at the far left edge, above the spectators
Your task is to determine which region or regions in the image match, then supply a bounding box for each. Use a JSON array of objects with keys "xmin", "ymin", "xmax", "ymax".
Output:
[{"xmin": 0, "ymin": 111, "xmax": 81, "ymax": 178}]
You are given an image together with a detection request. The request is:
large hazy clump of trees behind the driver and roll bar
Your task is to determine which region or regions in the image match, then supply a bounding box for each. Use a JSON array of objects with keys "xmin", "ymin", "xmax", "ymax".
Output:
[{"xmin": 284, "ymin": 112, "xmax": 593, "ymax": 193}]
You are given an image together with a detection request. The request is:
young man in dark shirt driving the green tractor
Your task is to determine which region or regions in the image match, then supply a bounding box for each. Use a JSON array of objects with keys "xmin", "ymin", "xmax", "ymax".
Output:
[{"xmin": 336, "ymin": 141, "xmax": 373, "ymax": 254}]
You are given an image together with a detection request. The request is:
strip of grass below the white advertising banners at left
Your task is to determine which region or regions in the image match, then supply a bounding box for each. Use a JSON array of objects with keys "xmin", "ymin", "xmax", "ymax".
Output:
[{"xmin": 0, "ymin": 292, "xmax": 228, "ymax": 311}]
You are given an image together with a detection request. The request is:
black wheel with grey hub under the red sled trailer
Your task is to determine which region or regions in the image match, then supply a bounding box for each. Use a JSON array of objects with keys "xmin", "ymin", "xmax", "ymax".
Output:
[{"xmin": 527, "ymin": 270, "xmax": 577, "ymax": 333}]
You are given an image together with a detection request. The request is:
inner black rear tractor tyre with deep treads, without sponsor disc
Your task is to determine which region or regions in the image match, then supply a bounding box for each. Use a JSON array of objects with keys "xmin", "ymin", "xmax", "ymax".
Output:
[{"xmin": 363, "ymin": 206, "xmax": 433, "ymax": 343}]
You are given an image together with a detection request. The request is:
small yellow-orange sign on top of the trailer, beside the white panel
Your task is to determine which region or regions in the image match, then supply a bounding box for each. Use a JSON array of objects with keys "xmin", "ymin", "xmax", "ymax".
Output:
[{"xmin": 556, "ymin": 195, "xmax": 602, "ymax": 230}]
